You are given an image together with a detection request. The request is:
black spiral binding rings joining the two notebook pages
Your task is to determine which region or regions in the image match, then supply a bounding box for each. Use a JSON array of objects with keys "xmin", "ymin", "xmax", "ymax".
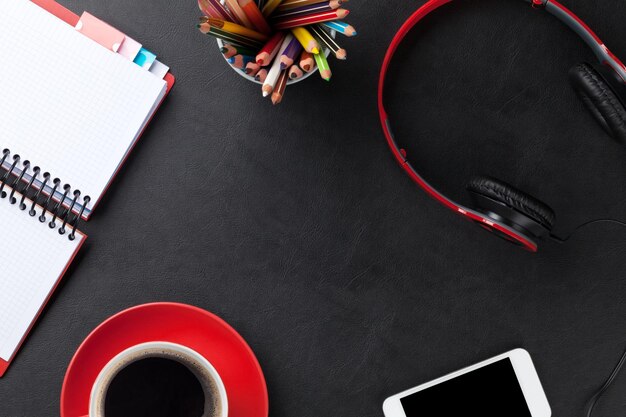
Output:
[{"xmin": 0, "ymin": 149, "xmax": 91, "ymax": 240}]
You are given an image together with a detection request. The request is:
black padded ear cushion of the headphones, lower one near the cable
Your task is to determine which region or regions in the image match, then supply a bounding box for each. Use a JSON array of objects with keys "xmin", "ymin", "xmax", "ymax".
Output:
[{"xmin": 467, "ymin": 176, "xmax": 555, "ymax": 237}]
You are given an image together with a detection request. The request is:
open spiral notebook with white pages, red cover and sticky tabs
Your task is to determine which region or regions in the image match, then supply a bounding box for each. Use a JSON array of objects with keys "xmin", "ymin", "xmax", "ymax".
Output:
[{"xmin": 0, "ymin": 0, "xmax": 174, "ymax": 376}]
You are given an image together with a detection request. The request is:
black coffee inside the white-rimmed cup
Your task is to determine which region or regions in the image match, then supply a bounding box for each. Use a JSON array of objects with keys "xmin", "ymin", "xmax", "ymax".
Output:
[{"xmin": 104, "ymin": 357, "xmax": 205, "ymax": 417}]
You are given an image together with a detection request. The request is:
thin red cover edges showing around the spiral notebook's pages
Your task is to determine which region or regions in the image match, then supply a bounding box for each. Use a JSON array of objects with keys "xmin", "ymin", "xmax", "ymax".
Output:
[{"xmin": 0, "ymin": 0, "xmax": 176, "ymax": 377}]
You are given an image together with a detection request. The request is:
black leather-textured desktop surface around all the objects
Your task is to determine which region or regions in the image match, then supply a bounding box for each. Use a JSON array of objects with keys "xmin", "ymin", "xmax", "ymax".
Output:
[{"xmin": 0, "ymin": 0, "xmax": 626, "ymax": 417}]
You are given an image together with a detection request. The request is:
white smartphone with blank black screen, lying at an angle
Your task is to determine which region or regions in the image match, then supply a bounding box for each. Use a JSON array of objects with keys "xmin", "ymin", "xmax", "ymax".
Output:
[{"xmin": 383, "ymin": 349, "xmax": 552, "ymax": 417}]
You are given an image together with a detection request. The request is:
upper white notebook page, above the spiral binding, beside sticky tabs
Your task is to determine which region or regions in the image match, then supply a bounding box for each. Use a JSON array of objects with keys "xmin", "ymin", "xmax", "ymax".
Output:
[{"xmin": 0, "ymin": 0, "xmax": 166, "ymax": 218}]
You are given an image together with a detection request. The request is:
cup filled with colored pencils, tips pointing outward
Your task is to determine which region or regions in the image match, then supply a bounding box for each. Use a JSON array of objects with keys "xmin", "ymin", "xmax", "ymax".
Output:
[{"xmin": 196, "ymin": 0, "xmax": 356, "ymax": 101}]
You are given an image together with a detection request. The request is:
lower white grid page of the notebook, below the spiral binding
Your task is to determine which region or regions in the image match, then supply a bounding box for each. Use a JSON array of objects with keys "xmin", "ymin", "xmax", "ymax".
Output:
[{"xmin": 0, "ymin": 187, "xmax": 85, "ymax": 361}]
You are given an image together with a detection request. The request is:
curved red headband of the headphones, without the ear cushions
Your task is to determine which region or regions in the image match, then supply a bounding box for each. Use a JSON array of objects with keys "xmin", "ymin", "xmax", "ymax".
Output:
[{"xmin": 378, "ymin": 0, "xmax": 626, "ymax": 252}]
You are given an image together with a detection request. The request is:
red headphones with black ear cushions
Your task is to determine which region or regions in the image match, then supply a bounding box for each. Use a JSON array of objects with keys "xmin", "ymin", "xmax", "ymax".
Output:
[{"xmin": 378, "ymin": 0, "xmax": 626, "ymax": 252}]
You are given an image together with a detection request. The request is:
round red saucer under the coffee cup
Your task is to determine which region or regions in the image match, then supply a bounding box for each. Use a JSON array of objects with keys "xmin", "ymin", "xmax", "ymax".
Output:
[{"xmin": 61, "ymin": 303, "xmax": 269, "ymax": 417}]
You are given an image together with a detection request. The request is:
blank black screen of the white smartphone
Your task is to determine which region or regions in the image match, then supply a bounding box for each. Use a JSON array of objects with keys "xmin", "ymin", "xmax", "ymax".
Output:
[{"xmin": 400, "ymin": 358, "xmax": 532, "ymax": 417}]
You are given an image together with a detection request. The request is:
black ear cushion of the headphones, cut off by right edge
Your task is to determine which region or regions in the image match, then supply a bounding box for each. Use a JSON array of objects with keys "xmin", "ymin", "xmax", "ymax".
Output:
[{"xmin": 569, "ymin": 63, "xmax": 626, "ymax": 144}]
